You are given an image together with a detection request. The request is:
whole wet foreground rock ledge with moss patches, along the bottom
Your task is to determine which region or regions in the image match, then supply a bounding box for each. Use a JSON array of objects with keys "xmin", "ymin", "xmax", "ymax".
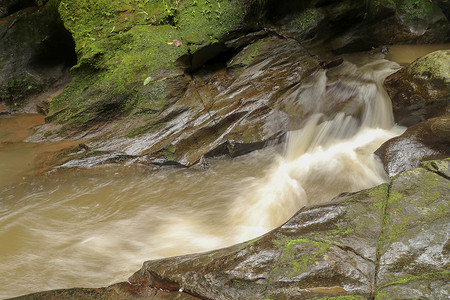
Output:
[{"xmin": 14, "ymin": 159, "xmax": 450, "ymax": 299}]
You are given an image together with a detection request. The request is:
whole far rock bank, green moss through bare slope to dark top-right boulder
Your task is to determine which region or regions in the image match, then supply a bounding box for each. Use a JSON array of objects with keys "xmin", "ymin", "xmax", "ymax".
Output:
[{"xmin": 3, "ymin": 1, "xmax": 442, "ymax": 166}]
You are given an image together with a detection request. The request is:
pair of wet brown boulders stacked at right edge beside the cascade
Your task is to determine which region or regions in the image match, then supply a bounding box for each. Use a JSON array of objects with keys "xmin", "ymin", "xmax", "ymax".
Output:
[{"xmin": 376, "ymin": 50, "xmax": 450, "ymax": 176}]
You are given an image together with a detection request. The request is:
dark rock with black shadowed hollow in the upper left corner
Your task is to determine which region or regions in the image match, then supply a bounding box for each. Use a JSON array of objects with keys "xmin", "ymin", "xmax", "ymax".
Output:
[{"xmin": 0, "ymin": 0, "xmax": 76, "ymax": 108}]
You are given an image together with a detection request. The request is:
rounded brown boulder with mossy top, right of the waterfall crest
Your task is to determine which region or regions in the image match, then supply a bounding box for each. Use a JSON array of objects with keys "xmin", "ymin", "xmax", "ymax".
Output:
[{"xmin": 385, "ymin": 50, "xmax": 450, "ymax": 126}]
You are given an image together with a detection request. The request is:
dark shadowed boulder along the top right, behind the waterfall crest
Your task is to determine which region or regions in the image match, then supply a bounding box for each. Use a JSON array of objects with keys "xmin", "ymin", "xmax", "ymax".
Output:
[{"xmin": 256, "ymin": 0, "xmax": 450, "ymax": 53}]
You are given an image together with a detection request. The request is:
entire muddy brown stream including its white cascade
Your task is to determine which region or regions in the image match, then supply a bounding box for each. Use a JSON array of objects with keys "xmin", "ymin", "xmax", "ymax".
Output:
[{"xmin": 0, "ymin": 53, "xmax": 403, "ymax": 298}]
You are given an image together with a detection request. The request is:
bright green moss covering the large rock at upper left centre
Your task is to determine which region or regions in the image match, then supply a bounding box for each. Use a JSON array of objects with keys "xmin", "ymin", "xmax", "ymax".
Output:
[{"xmin": 48, "ymin": 0, "xmax": 247, "ymax": 135}]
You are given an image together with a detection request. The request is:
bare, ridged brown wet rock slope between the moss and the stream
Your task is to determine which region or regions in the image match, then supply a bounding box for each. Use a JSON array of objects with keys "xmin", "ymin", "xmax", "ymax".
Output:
[{"xmin": 59, "ymin": 37, "xmax": 321, "ymax": 166}]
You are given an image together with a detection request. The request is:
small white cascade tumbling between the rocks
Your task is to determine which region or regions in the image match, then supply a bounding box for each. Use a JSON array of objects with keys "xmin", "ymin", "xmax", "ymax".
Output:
[{"xmin": 231, "ymin": 59, "xmax": 404, "ymax": 239}]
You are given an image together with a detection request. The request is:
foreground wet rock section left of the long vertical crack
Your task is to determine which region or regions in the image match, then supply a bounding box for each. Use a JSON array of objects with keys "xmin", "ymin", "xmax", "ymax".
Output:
[{"xmin": 119, "ymin": 185, "xmax": 387, "ymax": 299}]
